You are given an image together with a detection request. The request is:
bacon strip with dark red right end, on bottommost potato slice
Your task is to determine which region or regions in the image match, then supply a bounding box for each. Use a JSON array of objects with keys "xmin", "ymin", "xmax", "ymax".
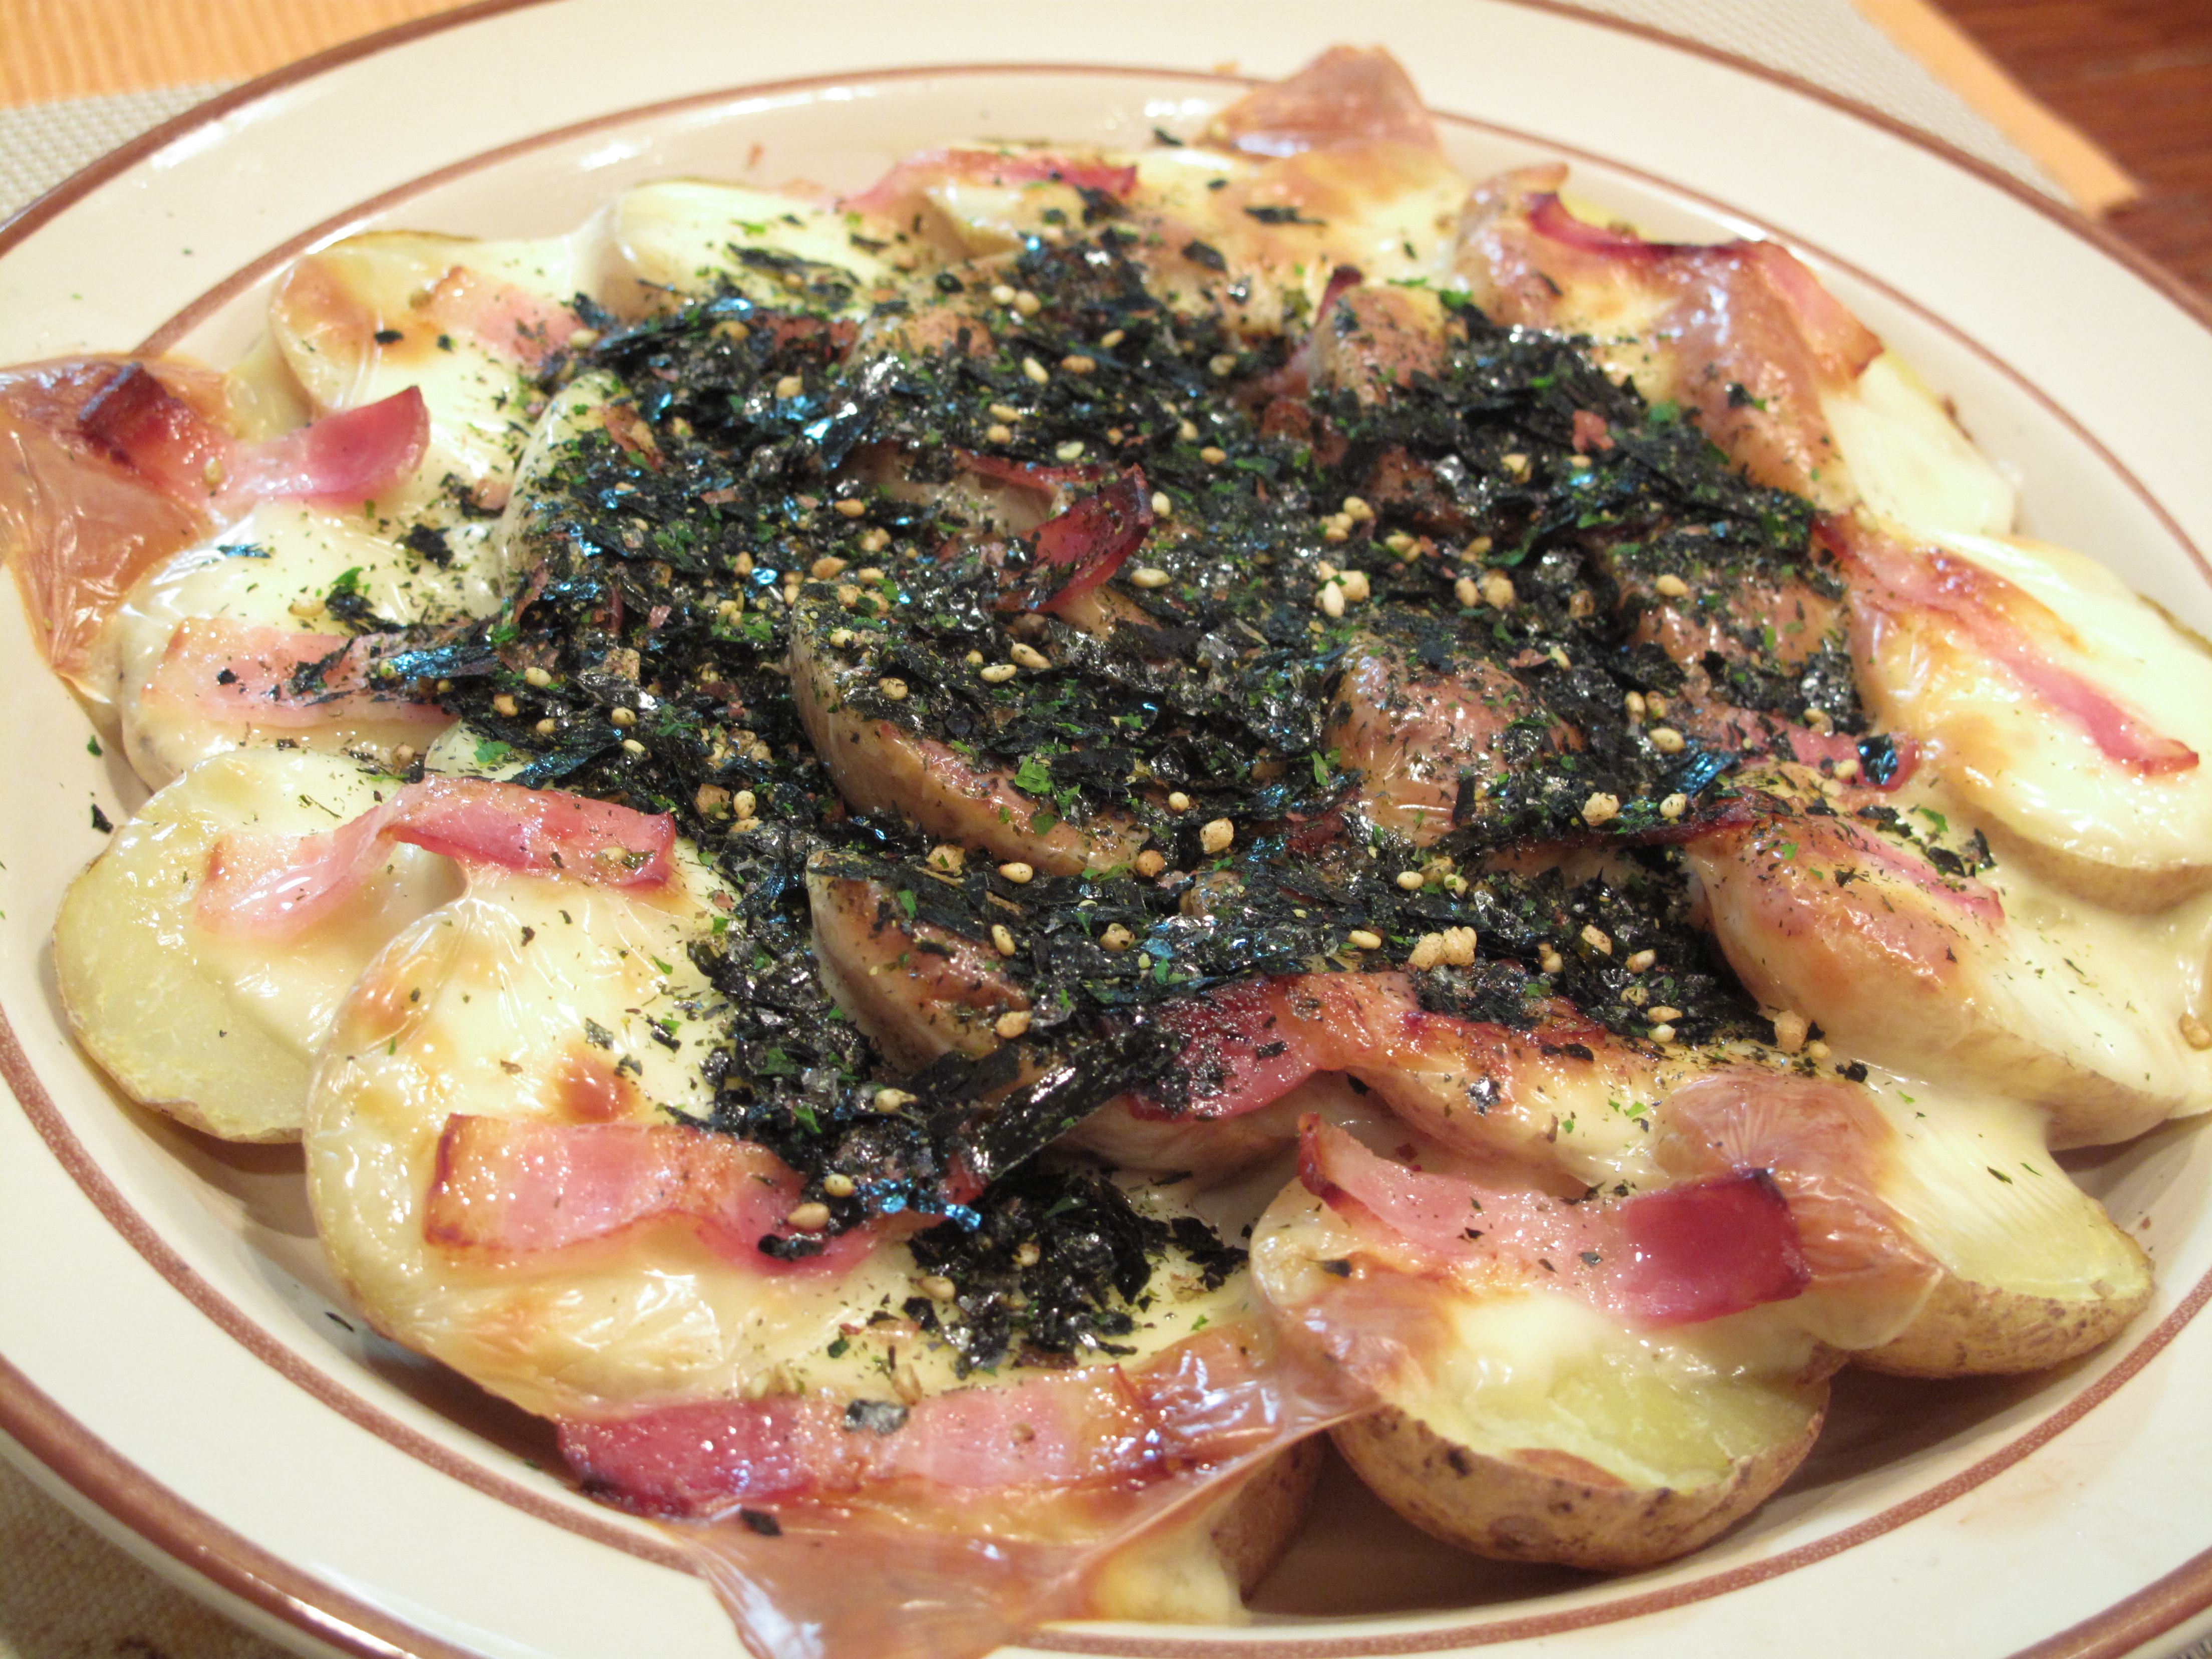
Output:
[{"xmin": 1298, "ymin": 1117, "xmax": 1812, "ymax": 1329}]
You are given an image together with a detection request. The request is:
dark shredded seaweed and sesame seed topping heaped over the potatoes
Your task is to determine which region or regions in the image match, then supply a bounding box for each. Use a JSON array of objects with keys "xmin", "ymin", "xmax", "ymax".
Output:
[{"xmin": 349, "ymin": 223, "xmax": 1884, "ymax": 1365}]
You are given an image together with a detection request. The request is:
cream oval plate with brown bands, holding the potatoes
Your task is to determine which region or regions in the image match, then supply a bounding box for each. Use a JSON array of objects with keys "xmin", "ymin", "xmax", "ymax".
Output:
[{"xmin": 0, "ymin": 0, "xmax": 2212, "ymax": 1659}]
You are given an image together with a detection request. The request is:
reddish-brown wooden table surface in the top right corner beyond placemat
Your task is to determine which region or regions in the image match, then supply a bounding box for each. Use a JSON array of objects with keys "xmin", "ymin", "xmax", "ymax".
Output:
[{"xmin": 1938, "ymin": 0, "xmax": 2212, "ymax": 301}]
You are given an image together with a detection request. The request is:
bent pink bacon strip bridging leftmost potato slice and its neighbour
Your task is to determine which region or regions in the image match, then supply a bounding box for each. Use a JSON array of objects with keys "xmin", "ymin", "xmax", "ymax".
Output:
[{"xmin": 199, "ymin": 776, "xmax": 677, "ymax": 940}]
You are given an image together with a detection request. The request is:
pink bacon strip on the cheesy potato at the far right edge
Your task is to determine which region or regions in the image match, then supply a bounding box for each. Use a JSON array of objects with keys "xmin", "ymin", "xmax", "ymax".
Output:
[{"xmin": 1823, "ymin": 520, "xmax": 2199, "ymax": 776}]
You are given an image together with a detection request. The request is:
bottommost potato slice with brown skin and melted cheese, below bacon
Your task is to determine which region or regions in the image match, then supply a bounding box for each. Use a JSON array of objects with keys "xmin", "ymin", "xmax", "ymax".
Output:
[{"xmin": 1252, "ymin": 1186, "xmax": 1831, "ymax": 1570}]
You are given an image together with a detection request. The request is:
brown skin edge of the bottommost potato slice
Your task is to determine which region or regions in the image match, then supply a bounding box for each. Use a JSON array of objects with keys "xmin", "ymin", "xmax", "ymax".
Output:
[{"xmin": 1329, "ymin": 1385, "xmax": 1827, "ymax": 1573}]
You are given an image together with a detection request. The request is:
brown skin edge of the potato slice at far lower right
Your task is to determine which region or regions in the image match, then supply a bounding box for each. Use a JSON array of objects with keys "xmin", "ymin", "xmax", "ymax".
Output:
[{"xmin": 1851, "ymin": 1265, "xmax": 2150, "ymax": 1378}]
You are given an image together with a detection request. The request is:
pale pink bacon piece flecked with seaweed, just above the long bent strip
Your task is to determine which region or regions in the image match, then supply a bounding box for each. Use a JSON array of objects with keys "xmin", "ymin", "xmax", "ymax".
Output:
[{"xmin": 142, "ymin": 617, "xmax": 453, "ymax": 732}]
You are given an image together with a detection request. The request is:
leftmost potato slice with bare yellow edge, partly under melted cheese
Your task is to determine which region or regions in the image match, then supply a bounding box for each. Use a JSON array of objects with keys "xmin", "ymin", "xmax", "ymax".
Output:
[{"xmin": 53, "ymin": 750, "xmax": 460, "ymax": 1142}]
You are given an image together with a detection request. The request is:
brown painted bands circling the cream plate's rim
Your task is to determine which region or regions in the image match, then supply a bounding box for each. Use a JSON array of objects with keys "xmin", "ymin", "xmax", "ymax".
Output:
[{"xmin": 0, "ymin": 0, "xmax": 2212, "ymax": 1659}]
